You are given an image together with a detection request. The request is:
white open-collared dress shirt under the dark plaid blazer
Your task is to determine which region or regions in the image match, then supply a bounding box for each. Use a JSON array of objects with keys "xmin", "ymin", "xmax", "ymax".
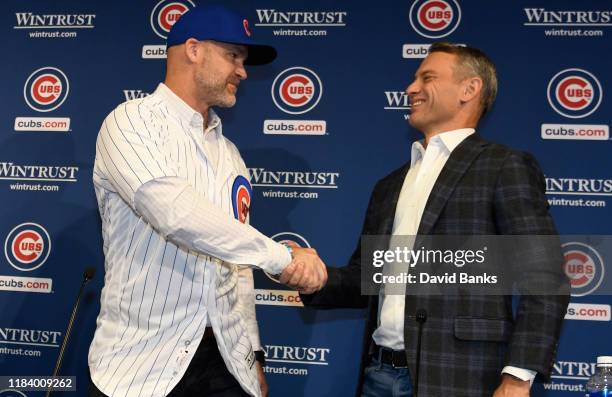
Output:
[{"xmin": 372, "ymin": 128, "xmax": 535, "ymax": 380}]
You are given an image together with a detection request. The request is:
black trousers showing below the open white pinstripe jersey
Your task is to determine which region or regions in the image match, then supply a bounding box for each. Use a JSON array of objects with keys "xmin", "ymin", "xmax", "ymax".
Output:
[{"xmin": 89, "ymin": 329, "xmax": 248, "ymax": 397}]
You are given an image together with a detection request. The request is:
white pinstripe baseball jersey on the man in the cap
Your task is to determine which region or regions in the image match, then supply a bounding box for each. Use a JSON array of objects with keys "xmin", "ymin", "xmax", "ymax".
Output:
[{"xmin": 89, "ymin": 84, "xmax": 290, "ymax": 397}]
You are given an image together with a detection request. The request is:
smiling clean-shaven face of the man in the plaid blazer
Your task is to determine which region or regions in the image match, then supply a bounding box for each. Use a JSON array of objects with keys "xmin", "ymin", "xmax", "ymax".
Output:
[{"xmin": 406, "ymin": 52, "xmax": 465, "ymax": 136}]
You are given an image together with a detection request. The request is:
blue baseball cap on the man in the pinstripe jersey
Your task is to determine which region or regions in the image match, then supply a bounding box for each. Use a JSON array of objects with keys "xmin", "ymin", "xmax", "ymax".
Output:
[{"xmin": 166, "ymin": 6, "xmax": 276, "ymax": 65}]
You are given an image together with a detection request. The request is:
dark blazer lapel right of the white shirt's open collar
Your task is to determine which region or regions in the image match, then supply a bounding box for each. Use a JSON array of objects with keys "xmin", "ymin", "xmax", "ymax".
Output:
[{"xmin": 417, "ymin": 134, "xmax": 486, "ymax": 235}]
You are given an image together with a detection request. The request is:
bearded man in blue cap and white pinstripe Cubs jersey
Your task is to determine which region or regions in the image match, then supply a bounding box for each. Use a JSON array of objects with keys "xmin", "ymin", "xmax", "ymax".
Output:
[{"xmin": 88, "ymin": 3, "xmax": 327, "ymax": 397}]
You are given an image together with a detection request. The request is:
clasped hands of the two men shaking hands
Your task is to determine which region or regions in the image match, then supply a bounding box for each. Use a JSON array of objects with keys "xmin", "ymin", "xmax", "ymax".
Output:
[{"xmin": 278, "ymin": 244, "xmax": 327, "ymax": 294}]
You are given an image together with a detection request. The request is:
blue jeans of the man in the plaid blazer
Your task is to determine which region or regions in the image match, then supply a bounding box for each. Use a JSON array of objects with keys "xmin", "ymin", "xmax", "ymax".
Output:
[{"xmin": 361, "ymin": 356, "xmax": 412, "ymax": 397}]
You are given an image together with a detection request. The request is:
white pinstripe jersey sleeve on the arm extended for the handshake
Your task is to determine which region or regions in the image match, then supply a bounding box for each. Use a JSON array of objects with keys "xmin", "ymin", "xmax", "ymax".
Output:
[{"xmin": 96, "ymin": 103, "xmax": 291, "ymax": 274}]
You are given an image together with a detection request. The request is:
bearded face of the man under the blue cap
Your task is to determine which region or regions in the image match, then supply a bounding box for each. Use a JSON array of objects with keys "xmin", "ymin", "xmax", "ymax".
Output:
[{"xmin": 195, "ymin": 41, "xmax": 247, "ymax": 107}]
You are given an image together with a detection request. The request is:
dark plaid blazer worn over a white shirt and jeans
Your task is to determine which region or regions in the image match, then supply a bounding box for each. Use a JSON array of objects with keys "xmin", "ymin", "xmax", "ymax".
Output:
[{"xmin": 302, "ymin": 134, "xmax": 569, "ymax": 397}]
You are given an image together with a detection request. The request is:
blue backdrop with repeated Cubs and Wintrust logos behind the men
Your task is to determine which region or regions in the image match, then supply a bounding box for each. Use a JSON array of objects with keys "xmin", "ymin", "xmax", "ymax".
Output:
[{"xmin": 0, "ymin": 0, "xmax": 612, "ymax": 397}]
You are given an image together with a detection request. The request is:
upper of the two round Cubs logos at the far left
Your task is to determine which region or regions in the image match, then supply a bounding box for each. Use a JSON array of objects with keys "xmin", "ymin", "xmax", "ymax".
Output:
[{"xmin": 23, "ymin": 66, "xmax": 70, "ymax": 112}]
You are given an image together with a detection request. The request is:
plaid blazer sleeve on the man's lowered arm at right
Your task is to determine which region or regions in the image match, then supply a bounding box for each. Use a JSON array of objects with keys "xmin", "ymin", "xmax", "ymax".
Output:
[{"xmin": 495, "ymin": 152, "xmax": 569, "ymax": 378}]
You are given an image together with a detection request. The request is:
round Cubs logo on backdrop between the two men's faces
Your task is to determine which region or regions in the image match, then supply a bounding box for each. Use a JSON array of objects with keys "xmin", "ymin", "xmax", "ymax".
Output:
[{"xmin": 272, "ymin": 66, "xmax": 323, "ymax": 114}]
